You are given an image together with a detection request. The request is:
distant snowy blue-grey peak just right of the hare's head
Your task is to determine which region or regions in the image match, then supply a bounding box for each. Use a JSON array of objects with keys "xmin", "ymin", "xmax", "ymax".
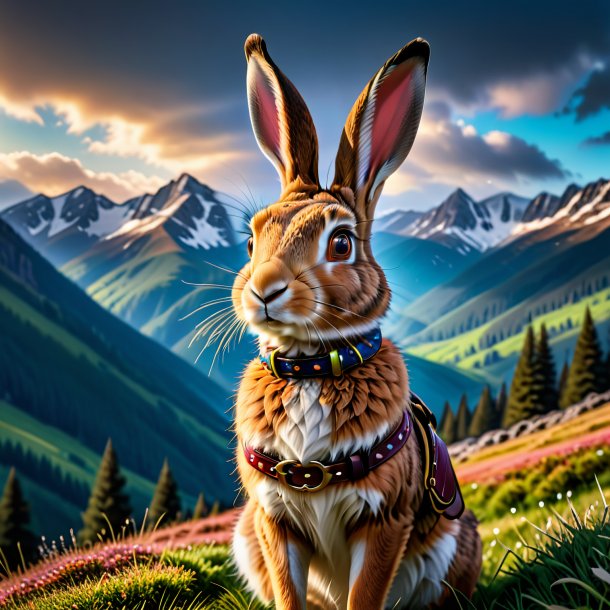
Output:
[{"xmin": 405, "ymin": 189, "xmax": 529, "ymax": 254}]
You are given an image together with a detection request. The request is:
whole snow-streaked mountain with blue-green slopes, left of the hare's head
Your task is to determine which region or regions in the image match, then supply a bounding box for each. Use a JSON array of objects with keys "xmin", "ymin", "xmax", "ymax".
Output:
[{"xmin": 2, "ymin": 174, "xmax": 252, "ymax": 391}]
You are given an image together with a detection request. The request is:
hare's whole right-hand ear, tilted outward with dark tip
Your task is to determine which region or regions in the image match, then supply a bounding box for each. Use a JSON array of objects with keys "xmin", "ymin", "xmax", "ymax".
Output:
[{"xmin": 333, "ymin": 38, "xmax": 430, "ymax": 218}]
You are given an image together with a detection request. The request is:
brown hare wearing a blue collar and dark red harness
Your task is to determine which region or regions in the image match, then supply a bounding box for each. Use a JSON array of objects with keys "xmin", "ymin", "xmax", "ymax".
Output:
[{"xmin": 232, "ymin": 34, "xmax": 481, "ymax": 610}]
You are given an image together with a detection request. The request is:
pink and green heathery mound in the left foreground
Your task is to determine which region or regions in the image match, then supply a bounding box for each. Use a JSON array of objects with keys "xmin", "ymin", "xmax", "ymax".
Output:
[{"xmin": 0, "ymin": 543, "xmax": 263, "ymax": 610}]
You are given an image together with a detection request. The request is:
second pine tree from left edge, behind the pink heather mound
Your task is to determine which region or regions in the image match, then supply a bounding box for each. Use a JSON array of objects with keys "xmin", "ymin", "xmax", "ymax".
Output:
[{"xmin": 78, "ymin": 439, "xmax": 131, "ymax": 544}]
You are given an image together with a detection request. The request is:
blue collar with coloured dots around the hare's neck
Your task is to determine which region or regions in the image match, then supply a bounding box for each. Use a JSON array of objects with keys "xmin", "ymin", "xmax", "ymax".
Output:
[{"xmin": 259, "ymin": 328, "xmax": 381, "ymax": 378}]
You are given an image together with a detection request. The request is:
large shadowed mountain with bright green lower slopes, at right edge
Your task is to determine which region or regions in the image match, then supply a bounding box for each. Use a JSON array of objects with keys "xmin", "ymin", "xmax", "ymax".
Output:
[{"xmin": 391, "ymin": 176, "xmax": 610, "ymax": 392}]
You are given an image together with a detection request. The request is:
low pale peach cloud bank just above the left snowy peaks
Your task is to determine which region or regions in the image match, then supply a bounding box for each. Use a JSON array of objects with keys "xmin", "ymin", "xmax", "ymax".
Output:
[{"xmin": 0, "ymin": 151, "xmax": 166, "ymax": 201}]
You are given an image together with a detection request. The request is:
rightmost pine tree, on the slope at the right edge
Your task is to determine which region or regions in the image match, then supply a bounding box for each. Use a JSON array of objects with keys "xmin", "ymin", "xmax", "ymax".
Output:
[{"xmin": 561, "ymin": 307, "xmax": 604, "ymax": 409}]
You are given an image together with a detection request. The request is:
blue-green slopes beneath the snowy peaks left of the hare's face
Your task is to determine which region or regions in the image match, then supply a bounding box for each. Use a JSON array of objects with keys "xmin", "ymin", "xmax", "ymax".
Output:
[{"xmin": 61, "ymin": 221, "xmax": 253, "ymax": 393}]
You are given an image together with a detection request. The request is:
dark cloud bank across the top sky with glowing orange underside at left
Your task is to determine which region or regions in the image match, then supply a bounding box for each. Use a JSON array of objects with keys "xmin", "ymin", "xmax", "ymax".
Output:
[{"xmin": 0, "ymin": 0, "xmax": 610, "ymax": 172}]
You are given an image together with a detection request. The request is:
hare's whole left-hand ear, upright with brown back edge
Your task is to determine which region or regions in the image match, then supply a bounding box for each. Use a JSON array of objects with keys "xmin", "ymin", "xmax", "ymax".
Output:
[{"xmin": 245, "ymin": 34, "xmax": 318, "ymax": 191}]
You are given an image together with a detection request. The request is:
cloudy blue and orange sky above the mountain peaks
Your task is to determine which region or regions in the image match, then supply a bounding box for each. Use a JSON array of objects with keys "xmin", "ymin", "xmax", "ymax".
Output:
[{"xmin": 0, "ymin": 0, "xmax": 610, "ymax": 211}]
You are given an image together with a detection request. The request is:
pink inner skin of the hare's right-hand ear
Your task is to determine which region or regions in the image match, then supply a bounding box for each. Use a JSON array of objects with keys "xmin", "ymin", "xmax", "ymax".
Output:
[{"xmin": 369, "ymin": 61, "xmax": 413, "ymax": 176}]
